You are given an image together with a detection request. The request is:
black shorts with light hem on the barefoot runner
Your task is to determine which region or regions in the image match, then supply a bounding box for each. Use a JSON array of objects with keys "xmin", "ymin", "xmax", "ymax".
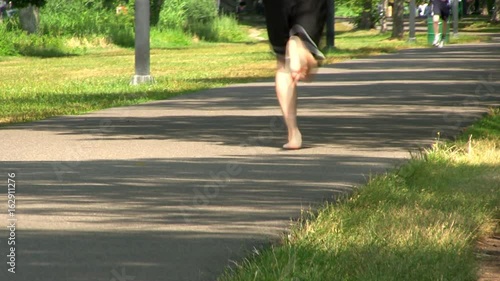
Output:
[{"xmin": 264, "ymin": 0, "xmax": 327, "ymax": 59}]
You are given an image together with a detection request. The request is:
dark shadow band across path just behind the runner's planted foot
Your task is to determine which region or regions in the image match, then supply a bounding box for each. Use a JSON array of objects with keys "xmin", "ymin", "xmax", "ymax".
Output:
[{"xmin": 8, "ymin": 105, "xmax": 488, "ymax": 149}]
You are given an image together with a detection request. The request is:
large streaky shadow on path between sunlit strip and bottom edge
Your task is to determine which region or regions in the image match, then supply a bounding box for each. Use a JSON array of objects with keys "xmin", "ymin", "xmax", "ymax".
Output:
[{"xmin": 0, "ymin": 154, "xmax": 395, "ymax": 281}]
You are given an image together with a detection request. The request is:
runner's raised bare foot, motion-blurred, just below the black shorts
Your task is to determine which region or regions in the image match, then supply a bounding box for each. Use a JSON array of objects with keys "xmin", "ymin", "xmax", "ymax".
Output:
[{"xmin": 287, "ymin": 36, "xmax": 318, "ymax": 82}]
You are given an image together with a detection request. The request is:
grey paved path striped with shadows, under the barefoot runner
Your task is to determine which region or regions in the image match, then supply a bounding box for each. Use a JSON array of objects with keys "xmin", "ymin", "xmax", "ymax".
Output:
[{"xmin": 0, "ymin": 37, "xmax": 500, "ymax": 281}]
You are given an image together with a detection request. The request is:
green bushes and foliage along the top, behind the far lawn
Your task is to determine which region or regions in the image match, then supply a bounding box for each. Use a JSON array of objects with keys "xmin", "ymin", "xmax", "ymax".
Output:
[{"xmin": 0, "ymin": 0, "xmax": 500, "ymax": 55}]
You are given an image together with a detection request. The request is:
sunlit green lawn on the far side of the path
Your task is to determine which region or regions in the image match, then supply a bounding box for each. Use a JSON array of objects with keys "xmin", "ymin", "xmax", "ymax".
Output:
[{"xmin": 0, "ymin": 26, "xmax": 490, "ymax": 126}]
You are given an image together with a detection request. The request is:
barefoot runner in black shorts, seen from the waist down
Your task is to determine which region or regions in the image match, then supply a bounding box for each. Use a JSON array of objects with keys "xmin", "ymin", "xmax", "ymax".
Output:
[{"xmin": 264, "ymin": 0, "xmax": 327, "ymax": 149}]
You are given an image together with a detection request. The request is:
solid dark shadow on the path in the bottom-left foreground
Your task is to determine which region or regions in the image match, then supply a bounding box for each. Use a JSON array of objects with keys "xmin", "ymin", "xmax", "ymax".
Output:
[{"xmin": 0, "ymin": 229, "xmax": 268, "ymax": 281}]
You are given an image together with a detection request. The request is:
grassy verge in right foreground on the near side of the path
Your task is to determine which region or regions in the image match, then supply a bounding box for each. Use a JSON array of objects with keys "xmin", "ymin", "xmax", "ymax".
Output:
[{"xmin": 219, "ymin": 109, "xmax": 500, "ymax": 281}]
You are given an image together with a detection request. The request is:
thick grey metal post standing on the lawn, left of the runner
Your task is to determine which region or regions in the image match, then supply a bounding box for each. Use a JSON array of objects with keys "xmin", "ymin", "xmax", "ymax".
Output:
[{"xmin": 131, "ymin": 0, "xmax": 154, "ymax": 85}]
